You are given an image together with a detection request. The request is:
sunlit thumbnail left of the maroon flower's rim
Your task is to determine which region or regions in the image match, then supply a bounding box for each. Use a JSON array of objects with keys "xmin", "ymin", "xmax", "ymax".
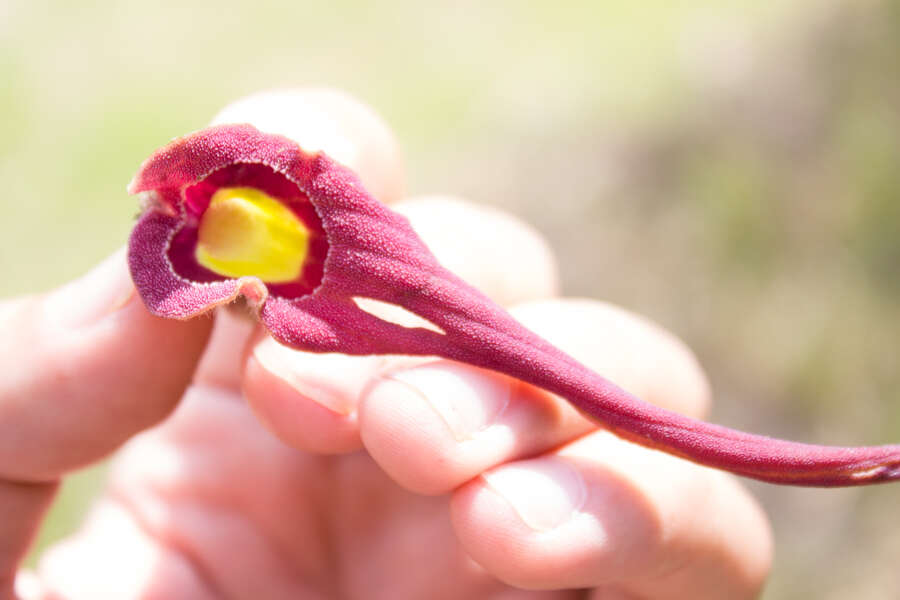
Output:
[{"xmin": 43, "ymin": 248, "xmax": 135, "ymax": 327}]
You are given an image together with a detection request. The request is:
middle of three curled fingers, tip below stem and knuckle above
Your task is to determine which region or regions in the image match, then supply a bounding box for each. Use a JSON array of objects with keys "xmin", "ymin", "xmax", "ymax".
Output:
[{"xmin": 359, "ymin": 300, "xmax": 709, "ymax": 494}]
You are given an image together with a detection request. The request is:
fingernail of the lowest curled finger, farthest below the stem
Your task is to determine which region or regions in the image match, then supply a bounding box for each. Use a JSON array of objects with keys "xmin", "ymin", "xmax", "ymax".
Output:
[{"xmin": 482, "ymin": 458, "xmax": 587, "ymax": 531}]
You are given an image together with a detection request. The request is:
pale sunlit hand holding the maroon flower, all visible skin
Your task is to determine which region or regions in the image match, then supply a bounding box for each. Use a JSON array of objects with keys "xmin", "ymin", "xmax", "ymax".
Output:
[{"xmin": 0, "ymin": 90, "xmax": 772, "ymax": 600}]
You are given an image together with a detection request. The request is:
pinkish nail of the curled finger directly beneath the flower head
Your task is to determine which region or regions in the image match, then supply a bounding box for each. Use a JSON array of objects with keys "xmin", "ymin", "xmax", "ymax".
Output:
[{"xmin": 253, "ymin": 337, "xmax": 382, "ymax": 415}]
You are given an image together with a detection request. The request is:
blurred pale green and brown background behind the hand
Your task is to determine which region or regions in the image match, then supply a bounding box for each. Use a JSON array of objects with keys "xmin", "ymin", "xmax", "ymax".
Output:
[{"xmin": 0, "ymin": 0, "xmax": 900, "ymax": 600}]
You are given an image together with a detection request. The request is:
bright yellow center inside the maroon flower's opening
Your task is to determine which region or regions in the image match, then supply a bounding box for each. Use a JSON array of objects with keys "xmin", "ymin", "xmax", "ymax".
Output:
[{"xmin": 194, "ymin": 187, "xmax": 309, "ymax": 283}]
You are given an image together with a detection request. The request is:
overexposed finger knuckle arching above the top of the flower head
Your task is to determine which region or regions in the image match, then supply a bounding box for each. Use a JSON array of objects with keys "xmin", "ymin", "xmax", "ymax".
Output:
[{"xmin": 213, "ymin": 87, "xmax": 404, "ymax": 203}]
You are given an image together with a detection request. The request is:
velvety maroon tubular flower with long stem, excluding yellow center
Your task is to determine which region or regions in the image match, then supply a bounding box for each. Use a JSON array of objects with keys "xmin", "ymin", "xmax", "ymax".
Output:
[{"xmin": 129, "ymin": 125, "xmax": 900, "ymax": 486}]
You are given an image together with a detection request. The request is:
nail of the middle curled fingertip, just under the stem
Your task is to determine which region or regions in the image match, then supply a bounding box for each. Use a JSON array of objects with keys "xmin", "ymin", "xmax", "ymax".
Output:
[{"xmin": 390, "ymin": 362, "xmax": 510, "ymax": 441}]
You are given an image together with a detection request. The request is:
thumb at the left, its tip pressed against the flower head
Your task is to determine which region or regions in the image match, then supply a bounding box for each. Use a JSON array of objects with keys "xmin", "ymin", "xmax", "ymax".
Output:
[{"xmin": 0, "ymin": 250, "xmax": 212, "ymax": 483}]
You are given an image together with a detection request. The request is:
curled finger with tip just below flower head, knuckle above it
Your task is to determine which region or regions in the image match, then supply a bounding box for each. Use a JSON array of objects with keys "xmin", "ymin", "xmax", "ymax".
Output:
[{"xmin": 244, "ymin": 197, "xmax": 557, "ymax": 453}]
